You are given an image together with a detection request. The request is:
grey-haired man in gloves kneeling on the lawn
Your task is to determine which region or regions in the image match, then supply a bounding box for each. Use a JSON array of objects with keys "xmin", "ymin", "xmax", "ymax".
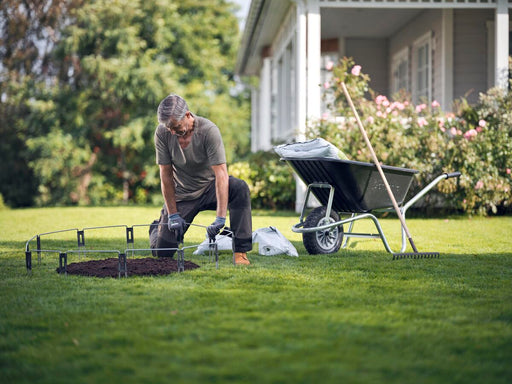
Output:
[{"xmin": 152, "ymin": 94, "xmax": 252, "ymax": 265}]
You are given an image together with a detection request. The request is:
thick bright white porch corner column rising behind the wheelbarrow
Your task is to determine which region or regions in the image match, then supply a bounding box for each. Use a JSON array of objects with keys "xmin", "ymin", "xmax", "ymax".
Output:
[{"xmin": 307, "ymin": 0, "xmax": 322, "ymax": 121}]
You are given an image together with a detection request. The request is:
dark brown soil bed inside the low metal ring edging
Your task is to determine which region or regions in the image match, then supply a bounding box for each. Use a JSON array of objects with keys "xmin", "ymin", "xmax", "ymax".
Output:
[{"xmin": 57, "ymin": 257, "xmax": 199, "ymax": 277}]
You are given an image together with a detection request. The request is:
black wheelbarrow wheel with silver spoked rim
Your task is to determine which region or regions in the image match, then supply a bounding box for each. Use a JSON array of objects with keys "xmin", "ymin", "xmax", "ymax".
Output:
[{"xmin": 302, "ymin": 207, "xmax": 343, "ymax": 255}]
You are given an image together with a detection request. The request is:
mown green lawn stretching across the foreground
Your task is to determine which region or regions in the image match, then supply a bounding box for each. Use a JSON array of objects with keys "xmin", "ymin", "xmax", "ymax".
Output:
[{"xmin": 0, "ymin": 207, "xmax": 512, "ymax": 384}]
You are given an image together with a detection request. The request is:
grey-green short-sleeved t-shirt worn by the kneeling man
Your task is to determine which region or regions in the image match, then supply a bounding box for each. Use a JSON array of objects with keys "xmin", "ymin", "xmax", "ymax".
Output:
[{"xmin": 155, "ymin": 116, "xmax": 226, "ymax": 201}]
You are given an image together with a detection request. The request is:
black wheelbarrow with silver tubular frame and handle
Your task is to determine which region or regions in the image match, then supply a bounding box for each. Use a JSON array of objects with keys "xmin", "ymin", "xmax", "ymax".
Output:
[{"xmin": 282, "ymin": 157, "xmax": 460, "ymax": 254}]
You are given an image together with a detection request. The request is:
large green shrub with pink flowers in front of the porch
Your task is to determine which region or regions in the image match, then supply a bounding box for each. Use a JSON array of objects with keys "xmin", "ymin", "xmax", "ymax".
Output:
[{"xmin": 308, "ymin": 58, "xmax": 512, "ymax": 214}]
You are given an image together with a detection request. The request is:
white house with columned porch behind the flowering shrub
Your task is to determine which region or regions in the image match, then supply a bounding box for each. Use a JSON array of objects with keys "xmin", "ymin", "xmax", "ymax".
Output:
[{"xmin": 236, "ymin": 0, "xmax": 512, "ymax": 210}]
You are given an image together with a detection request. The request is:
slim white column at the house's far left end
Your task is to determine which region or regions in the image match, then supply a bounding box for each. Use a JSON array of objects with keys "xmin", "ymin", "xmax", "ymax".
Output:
[{"xmin": 256, "ymin": 57, "xmax": 272, "ymax": 151}]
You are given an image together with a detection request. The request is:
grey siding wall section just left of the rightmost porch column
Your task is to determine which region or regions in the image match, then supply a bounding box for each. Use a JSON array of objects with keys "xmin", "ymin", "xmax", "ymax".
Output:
[{"xmin": 453, "ymin": 10, "xmax": 494, "ymax": 103}]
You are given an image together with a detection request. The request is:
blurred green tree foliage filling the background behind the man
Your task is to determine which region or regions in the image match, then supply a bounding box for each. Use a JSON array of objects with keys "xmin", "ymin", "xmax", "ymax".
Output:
[{"xmin": 0, "ymin": 0, "xmax": 249, "ymax": 205}]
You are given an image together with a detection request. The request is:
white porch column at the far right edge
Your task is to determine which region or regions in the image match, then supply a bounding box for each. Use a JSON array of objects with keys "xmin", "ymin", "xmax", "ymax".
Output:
[{"xmin": 494, "ymin": 0, "xmax": 509, "ymax": 89}]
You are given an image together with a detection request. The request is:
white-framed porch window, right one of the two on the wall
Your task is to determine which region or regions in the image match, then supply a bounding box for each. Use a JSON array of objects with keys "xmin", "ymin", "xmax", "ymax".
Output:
[{"xmin": 411, "ymin": 31, "xmax": 432, "ymax": 104}]
